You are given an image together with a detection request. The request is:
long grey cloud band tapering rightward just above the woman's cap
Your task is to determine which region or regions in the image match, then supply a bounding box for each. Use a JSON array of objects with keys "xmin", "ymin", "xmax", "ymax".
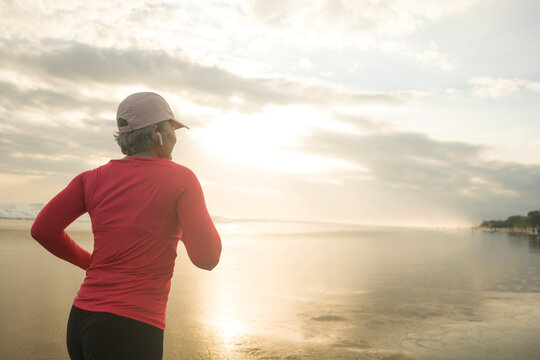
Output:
[{"xmin": 0, "ymin": 40, "xmax": 422, "ymax": 111}]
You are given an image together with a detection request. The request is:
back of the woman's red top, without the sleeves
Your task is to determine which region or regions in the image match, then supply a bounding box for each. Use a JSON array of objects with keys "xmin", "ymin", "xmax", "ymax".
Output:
[{"xmin": 74, "ymin": 156, "xmax": 213, "ymax": 328}]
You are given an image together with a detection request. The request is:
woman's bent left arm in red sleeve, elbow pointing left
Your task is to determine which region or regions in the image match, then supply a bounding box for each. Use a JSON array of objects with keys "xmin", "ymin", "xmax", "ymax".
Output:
[{"xmin": 30, "ymin": 174, "xmax": 92, "ymax": 270}]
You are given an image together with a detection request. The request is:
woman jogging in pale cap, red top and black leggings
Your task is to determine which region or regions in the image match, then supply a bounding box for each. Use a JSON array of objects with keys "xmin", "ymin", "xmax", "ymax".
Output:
[{"xmin": 31, "ymin": 92, "xmax": 221, "ymax": 360}]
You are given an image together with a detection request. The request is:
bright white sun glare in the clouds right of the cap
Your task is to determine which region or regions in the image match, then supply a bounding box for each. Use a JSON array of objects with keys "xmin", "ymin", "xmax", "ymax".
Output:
[{"xmin": 191, "ymin": 107, "xmax": 358, "ymax": 174}]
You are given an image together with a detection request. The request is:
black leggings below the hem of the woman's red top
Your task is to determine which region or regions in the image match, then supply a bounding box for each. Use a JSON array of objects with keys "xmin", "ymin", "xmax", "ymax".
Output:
[{"xmin": 67, "ymin": 306, "xmax": 163, "ymax": 360}]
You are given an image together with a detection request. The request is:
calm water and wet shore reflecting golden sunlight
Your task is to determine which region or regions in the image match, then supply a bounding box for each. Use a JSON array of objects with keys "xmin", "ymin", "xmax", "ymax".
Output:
[{"xmin": 0, "ymin": 220, "xmax": 540, "ymax": 359}]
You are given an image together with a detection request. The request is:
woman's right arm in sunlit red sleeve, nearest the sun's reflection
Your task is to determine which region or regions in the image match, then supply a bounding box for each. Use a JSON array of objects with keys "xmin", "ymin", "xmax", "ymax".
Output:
[{"xmin": 176, "ymin": 170, "xmax": 221, "ymax": 270}]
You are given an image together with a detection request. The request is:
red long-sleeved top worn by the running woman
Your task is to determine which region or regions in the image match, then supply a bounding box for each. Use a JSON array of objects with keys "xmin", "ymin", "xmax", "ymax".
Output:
[{"xmin": 31, "ymin": 156, "xmax": 221, "ymax": 329}]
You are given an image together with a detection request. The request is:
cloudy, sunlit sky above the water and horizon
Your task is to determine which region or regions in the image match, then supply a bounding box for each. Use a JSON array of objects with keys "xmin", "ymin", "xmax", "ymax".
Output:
[{"xmin": 0, "ymin": 0, "xmax": 540, "ymax": 226}]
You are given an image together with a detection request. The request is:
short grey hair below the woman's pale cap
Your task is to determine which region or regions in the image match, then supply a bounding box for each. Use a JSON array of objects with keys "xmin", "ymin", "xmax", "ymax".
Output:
[{"xmin": 114, "ymin": 120, "xmax": 174, "ymax": 155}]
